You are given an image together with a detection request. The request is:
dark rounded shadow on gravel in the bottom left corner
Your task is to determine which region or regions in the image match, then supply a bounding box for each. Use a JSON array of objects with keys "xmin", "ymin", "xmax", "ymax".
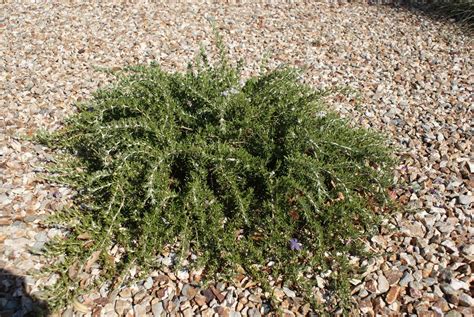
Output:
[{"xmin": 0, "ymin": 268, "xmax": 50, "ymax": 317}]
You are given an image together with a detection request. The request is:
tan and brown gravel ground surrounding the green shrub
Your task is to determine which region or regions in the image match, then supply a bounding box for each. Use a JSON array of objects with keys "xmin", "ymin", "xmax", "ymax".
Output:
[{"xmin": 0, "ymin": 1, "xmax": 474, "ymax": 317}]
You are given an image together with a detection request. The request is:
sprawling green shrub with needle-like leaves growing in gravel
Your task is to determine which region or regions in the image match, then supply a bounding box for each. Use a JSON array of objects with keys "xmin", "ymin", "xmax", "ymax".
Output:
[{"xmin": 38, "ymin": 35, "xmax": 394, "ymax": 311}]
